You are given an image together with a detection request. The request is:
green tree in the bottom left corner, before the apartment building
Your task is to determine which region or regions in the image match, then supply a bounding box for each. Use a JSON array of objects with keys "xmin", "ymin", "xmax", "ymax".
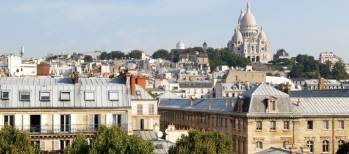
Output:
[{"xmin": 0, "ymin": 126, "xmax": 39, "ymax": 154}]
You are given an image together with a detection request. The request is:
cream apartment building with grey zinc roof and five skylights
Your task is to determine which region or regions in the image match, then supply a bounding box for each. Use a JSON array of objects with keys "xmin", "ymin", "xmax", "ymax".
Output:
[{"xmin": 0, "ymin": 77, "xmax": 133, "ymax": 152}]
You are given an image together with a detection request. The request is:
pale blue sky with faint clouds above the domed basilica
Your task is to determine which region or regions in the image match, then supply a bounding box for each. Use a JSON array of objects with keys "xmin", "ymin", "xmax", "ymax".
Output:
[{"xmin": 0, "ymin": 0, "xmax": 349, "ymax": 62}]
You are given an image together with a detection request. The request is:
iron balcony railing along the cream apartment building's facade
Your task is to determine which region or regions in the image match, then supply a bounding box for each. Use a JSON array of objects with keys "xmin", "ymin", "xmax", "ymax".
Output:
[{"xmin": 0, "ymin": 124, "xmax": 128, "ymax": 134}]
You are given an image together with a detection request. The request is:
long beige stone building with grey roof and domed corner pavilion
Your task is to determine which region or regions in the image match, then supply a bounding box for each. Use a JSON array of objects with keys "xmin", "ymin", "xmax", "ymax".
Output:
[{"xmin": 159, "ymin": 84, "xmax": 349, "ymax": 154}]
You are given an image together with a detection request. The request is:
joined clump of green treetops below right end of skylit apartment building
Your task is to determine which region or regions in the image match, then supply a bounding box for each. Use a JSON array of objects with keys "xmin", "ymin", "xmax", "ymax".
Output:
[{"xmin": 66, "ymin": 127, "xmax": 154, "ymax": 154}]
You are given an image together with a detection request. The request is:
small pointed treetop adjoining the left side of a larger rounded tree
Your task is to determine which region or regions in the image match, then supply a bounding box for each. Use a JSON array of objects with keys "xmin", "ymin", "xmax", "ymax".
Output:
[{"xmin": 65, "ymin": 134, "xmax": 90, "ymax": 154}]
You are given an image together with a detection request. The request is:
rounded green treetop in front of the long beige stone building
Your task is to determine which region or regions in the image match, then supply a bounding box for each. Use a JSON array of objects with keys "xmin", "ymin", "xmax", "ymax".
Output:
[{"xmin": 168, "ymin": 131, "xmax": 232, "ymax": 154}]
